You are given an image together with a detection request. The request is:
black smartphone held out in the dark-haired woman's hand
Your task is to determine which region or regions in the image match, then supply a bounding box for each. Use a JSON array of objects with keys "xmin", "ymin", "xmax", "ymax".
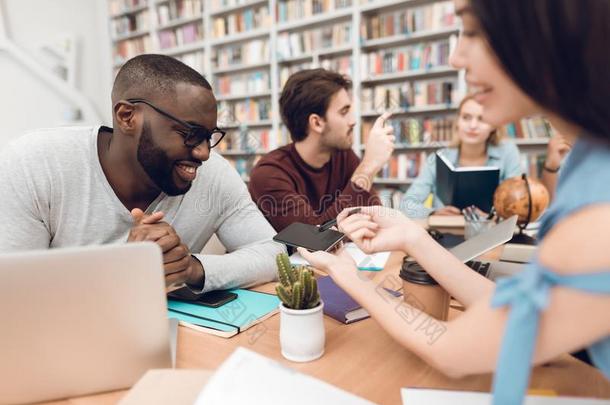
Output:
[{"xmin": 273, "ymin": 222, "xmax": 345, "ymax": 252}]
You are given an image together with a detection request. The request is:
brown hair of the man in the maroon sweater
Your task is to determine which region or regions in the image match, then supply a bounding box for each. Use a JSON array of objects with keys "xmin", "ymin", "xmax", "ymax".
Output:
[{"xmin": 280, "ymin": 69, "xmax": 352, "ymax": 142}]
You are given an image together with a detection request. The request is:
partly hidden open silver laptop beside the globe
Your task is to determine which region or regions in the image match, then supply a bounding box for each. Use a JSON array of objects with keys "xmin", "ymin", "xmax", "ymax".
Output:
[{"xmin": 449, "ymin": 215, "xmax": 523, "ymax": 280}]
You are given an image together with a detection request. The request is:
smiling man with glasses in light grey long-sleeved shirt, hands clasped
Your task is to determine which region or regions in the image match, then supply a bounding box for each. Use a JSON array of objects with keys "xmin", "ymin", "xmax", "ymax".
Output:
[{"xmin": 0, "ymin": 55, "xmax": 284, "ymax": 293}]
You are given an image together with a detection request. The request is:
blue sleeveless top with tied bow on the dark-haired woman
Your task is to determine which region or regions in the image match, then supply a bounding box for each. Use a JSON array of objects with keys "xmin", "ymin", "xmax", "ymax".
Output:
[{"xmin": 491, "ymin": 138, "xmax": 610, "ymax": 405}]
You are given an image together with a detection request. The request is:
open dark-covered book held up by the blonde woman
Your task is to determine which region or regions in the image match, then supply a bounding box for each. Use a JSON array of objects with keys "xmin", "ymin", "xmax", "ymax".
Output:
[{"xmin": 436, "ymin": 152, "xmax": 500, "ymax": 212}]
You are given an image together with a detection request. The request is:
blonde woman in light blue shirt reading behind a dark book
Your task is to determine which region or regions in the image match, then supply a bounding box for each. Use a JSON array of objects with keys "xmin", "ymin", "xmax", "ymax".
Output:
[{"xmin": 400, "ymin": 96, "xmax": 522, "ymax": 218}]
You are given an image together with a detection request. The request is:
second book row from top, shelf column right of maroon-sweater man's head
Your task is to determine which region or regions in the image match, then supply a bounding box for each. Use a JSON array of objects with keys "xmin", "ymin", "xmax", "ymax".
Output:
[{"xmin": 360, "ymin": 40, "xmax": 450, "ymax": 77}]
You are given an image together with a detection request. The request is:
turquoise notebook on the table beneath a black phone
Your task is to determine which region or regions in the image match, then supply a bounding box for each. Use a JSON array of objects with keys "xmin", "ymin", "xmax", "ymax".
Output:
[{"xmin": 167, "ymin": 289, "xmax": 280, "ymax": 338}]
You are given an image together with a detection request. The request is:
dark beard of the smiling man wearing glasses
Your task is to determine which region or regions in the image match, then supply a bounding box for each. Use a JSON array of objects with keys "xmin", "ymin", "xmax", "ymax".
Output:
[{"xmin": 137, "ymin": 122, "xmax": 191, "ymax": 196}]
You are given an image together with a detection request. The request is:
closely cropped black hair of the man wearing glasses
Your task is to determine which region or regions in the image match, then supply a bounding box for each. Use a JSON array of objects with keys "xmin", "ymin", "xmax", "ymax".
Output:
[{"xmin": 112, "ymin": 54, "xmax": 212, "ymax": 104}]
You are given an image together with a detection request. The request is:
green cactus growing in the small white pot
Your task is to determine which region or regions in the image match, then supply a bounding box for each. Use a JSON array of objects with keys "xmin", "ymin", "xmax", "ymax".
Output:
[{"xmin": 275, "ymin": 253, "xmax": 320, "ymax": 309}]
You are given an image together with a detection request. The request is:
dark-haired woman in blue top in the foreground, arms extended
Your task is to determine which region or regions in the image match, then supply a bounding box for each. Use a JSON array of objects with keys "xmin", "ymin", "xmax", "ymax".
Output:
[{"xmin": 301, "ymin": 0, "xmax": 610, "ymax": 405}]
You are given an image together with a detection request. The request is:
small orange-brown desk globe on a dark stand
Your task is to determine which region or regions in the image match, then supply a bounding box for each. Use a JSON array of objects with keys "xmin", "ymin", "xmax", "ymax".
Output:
[{"xmin": 494, "ymin": 174, "xmax": 549, "ymax": 245}]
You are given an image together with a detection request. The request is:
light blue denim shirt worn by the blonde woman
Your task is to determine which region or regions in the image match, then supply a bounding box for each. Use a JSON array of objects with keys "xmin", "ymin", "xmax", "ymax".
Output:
[{"xmin": 400, "ymin": 140, "xmax": 523, "ymax": 218}]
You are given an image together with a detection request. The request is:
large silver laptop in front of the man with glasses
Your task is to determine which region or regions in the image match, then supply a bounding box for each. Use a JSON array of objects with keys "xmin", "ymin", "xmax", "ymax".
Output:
[{"xmin": 0, "ymin": 243, "xmax": 171, "ymax": 404}]
